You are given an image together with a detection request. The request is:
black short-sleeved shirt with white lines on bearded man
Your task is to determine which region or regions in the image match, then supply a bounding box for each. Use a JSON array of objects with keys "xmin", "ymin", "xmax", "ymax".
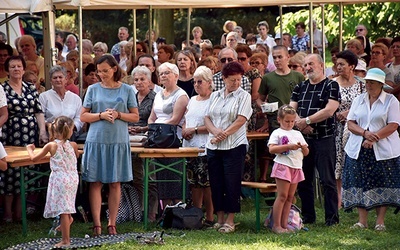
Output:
[{"xmin": 291, "ymin": 78, "xmax": 340, "ymax": 139}]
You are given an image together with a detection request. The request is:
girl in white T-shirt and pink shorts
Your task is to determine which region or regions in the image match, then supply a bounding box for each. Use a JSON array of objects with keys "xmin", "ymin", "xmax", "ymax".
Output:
[{"xmin": 268, "ymin": 105, "xmax": 309, "ymax": 233}]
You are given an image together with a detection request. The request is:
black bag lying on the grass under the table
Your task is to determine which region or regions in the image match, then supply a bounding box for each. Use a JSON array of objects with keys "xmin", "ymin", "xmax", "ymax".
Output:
[{"xmin": 158, "ymin": 207, "xmax": 203, "ymax": 229}]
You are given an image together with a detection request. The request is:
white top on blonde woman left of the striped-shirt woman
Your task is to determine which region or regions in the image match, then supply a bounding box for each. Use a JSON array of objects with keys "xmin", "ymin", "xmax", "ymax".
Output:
[{"xmin": 182, "ymin": 96, "xmax": 210, "ymax": 156}]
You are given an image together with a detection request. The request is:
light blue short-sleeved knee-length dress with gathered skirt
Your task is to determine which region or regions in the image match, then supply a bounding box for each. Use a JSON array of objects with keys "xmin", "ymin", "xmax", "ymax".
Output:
[{"xmin": 82, "ymin": 83, "xmax": 137, "ymax": 183}]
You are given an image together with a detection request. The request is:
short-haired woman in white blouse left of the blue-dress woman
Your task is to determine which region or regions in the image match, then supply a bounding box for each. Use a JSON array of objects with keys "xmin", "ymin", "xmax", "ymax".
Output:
[{"xmin": 39, "ymin": 65, "xmax": 83, "ymax": 139}]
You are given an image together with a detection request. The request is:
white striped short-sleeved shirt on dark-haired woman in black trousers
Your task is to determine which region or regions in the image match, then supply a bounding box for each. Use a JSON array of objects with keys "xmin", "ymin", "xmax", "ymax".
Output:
[{"xmin": 206, "ymin": 88, "xmax": 253, "ymax": 150}]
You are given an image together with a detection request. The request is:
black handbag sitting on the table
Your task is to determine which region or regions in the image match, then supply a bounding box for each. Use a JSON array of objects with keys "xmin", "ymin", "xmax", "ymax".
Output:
[{"xmin": 144, "ymin": 123, "xmax": 182, "ymax": 148}]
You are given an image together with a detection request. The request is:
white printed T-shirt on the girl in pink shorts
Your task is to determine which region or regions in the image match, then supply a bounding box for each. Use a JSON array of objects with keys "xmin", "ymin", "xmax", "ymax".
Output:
[{"xmin": 268, "ymin": 128, "xmax": 308, "ymax": 169}]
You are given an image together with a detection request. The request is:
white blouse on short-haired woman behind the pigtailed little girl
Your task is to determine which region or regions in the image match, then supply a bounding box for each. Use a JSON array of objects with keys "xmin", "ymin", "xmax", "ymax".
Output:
[{"xmin": 39, "ymin": 89, "xmax": 83, "ymax": 131}]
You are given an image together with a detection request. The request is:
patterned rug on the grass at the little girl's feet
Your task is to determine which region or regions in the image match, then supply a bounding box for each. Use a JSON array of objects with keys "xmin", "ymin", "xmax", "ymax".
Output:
[{"xmin": 7, "ymin": 231, "xmax": 164, "ymax": 250}]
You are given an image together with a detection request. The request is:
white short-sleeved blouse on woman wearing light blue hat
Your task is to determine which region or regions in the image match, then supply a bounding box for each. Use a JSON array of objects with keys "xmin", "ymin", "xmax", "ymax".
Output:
[{"xmin": 344, "ymin": 91, "xmax": 400, "ymax": 161}]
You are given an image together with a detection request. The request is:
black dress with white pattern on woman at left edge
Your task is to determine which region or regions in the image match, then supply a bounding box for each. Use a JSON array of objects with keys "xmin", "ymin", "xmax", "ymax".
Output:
[{"xmin": 0, "ymin": 81, "xmax": 42, "ymax": 194}]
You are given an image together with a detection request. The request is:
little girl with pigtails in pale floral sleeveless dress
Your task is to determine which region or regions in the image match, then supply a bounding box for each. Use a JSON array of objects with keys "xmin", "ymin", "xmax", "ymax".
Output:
[{"xmin": 26, "ymin": 116, "xmax": 79, "ymax": 248}]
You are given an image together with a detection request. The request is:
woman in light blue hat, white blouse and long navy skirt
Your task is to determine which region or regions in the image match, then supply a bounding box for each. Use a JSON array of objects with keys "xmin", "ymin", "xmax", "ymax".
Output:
[{"xmin": 342, "ymin": 68, "xmax": 400, "ymax": 231}]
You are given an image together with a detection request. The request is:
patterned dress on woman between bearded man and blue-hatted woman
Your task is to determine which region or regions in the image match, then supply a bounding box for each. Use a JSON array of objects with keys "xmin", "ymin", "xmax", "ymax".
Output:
[{"xmin": 334, "ymin": 77, "xmax": 365, "ymax": 180}]
